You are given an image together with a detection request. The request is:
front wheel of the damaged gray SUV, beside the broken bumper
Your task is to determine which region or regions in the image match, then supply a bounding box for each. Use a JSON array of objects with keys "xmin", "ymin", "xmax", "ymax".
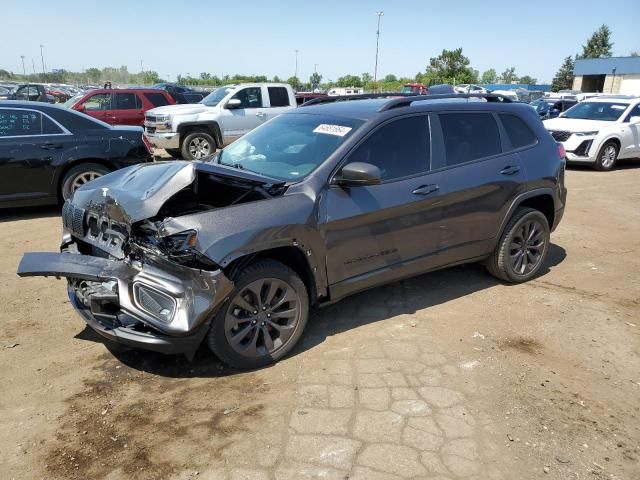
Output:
[{"xmin": 207, "ymin": 260, "xmax": 309, "ymax": 369}]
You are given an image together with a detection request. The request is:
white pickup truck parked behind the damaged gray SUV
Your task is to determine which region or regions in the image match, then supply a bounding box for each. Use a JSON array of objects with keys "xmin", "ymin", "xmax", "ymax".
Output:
[{"xmin": 144, "ymin": 83, "xmax": 296, "ymax": 160}]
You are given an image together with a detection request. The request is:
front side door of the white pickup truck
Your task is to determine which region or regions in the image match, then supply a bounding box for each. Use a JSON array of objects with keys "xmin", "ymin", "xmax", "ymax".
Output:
[{"xmin": 221, "ymin": 87, "xmax": 267, "ymax": 144}]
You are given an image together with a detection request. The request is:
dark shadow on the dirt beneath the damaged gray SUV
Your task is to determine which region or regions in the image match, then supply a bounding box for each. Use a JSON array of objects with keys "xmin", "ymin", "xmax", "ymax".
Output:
[{"xmin": 85, "ymin": 244, "xmax": 567, "ymax": 378}]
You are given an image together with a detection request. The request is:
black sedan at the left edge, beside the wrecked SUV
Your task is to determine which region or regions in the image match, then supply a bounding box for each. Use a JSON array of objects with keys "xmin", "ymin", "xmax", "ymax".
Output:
[{"xmin": 0, "ymin": 101, "xmax": 153, "ymax": 207}]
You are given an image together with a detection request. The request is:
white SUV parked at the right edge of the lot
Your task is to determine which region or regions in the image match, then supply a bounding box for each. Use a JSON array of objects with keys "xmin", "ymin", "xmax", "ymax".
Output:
[{"xmin": 544, "ymin": 96, "xmax": 640, "ymax": 170}]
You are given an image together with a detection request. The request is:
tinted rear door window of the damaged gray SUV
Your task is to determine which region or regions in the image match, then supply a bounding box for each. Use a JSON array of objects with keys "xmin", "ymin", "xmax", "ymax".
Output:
[{"xmin": 440, "ymin": 113, "xmax": 502, "ymax": 166}]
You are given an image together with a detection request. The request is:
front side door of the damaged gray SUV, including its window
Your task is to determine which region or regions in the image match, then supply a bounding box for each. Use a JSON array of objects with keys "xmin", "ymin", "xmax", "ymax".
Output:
[{"xmin": 323, "ymin": 114, "xmax": 442, "ymax": 288}]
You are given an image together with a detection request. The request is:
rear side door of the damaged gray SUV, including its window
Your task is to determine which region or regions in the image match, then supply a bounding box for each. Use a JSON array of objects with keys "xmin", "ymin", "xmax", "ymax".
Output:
[{"xmin": 434, "ymin": 111, "xmax": 524, "ymax": 264}]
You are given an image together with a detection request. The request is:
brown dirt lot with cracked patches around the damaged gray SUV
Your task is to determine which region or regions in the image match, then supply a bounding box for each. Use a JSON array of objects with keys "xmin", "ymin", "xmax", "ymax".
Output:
[{"xmin": 0, "ymin": 162, "xmax": 640, "ymax": 480}]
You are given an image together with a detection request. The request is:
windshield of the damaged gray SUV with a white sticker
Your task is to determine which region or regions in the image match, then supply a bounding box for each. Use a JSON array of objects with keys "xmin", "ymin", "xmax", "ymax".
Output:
[{"xmin": 214, "ymin": 113, "xmax": 362, "ymax": 181}]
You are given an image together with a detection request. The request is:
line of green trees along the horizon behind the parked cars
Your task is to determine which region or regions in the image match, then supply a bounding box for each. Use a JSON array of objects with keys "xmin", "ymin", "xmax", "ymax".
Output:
[{"xmin": 0, "ymin": 25, "xmax": 624, "ymax": 91}]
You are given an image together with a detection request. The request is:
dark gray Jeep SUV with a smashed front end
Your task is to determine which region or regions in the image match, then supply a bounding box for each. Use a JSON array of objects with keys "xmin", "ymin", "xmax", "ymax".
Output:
[{"xmin": 18, "ymin": 94, "xmax": 566, "ymax": 368}]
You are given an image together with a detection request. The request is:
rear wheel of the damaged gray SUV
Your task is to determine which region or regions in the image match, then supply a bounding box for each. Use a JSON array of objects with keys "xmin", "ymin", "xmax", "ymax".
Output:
[{"xmin": 486, "ymin": 208, "xmax": 550, "ymax": 283}]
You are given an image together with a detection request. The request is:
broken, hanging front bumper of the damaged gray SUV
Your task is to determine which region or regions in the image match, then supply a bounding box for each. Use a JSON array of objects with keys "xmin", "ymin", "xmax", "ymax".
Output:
[{"xmin": 18, "ymin": 253, "xmax": 233, "ymax": 354}]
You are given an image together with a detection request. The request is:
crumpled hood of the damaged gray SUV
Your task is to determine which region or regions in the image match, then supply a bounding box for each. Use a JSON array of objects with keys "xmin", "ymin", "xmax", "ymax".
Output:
[{"xmin": 72, "ymin": 161, "xmax": 196, "ymax": 225}]
